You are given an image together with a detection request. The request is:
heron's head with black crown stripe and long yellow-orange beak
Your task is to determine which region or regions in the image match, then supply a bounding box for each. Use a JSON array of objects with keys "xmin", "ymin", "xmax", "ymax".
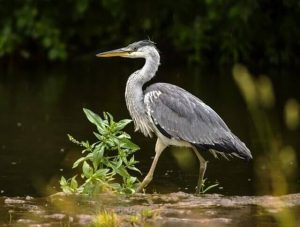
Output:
[{"xmin": 96, "ymin": 40, "xmax": 158, "ymax": 58}]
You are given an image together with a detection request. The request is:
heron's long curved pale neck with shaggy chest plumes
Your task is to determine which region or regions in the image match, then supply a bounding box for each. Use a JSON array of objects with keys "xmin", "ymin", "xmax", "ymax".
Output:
[{"xmin": 125, "ymin": 50, "xmax": 160, "ymax": 135}]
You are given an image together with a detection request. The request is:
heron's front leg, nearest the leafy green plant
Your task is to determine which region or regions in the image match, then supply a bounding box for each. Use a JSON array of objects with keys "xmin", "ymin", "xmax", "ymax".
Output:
[{"xmin": 136, "ymin": 138, "xmax": 167, "ymax": 192}]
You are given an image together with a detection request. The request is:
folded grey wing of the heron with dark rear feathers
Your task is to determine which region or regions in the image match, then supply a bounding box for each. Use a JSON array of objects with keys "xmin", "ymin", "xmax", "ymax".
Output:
[{"xmin": 144, "ymin": 83, "xmax": 251, "ymax": 159}]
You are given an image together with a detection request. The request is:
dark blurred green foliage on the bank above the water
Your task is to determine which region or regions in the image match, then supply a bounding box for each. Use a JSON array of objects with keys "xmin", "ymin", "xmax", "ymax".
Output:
[{"xmin": 0, "ymin": 0, "xmax": 300, "ymax": 64}]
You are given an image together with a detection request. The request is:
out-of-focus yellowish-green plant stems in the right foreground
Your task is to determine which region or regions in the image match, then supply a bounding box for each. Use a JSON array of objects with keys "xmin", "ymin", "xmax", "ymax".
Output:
[{"xmin": 232, "ymin": 64, "xmax": 300, "ymax": 227}]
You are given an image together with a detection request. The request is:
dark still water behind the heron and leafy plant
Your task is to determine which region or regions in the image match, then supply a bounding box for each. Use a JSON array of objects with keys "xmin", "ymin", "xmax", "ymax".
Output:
[{"xmin": 0, "ymin": 59, "xmax": 300, "ymax": 196}]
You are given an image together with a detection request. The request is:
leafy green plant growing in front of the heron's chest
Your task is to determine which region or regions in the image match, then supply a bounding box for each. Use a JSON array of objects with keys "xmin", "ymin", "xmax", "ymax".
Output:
[{"xmin": 60, "ymin": 109, "xmax": 140, "ymax": 194}]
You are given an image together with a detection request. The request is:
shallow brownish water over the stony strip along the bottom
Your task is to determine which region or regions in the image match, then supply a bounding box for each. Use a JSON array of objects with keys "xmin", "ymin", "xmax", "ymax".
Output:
[{"xmin": 0, "ymin": 192, "xmax": 300, "ymax": 226}]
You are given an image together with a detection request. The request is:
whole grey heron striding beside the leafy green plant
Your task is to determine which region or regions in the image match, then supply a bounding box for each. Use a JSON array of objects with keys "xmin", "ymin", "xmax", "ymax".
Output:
[{"xmin": 96, "ymin": 40, "xmax": 252, "ymax": 193}]
